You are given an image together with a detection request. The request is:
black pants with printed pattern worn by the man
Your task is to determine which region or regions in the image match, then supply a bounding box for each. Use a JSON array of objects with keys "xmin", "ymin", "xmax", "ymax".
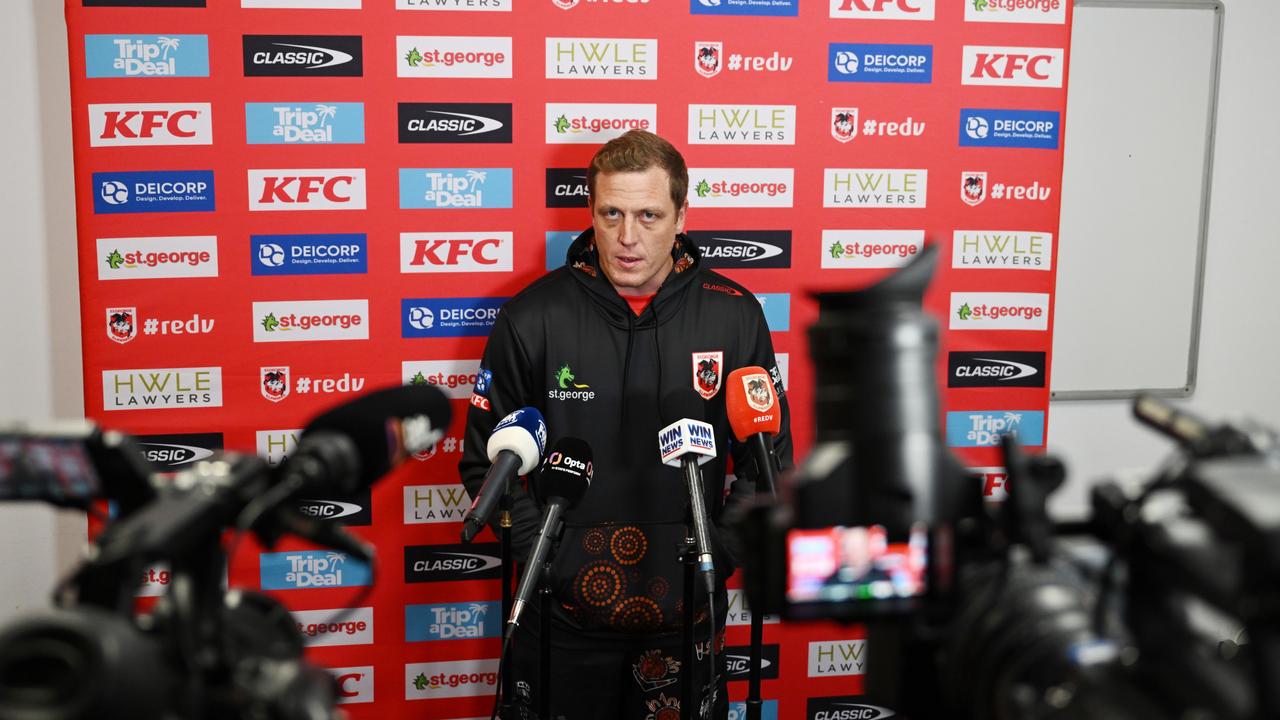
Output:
[{"xmin": 503, "ymin": 615, "xmax": 728, "ymax": 720}]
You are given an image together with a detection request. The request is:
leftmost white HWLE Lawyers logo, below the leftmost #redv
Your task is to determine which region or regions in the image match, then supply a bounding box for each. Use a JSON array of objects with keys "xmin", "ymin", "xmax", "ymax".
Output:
[{"xmin": 102, "ymin": 368, "xmax": 223, "ymax": 410}]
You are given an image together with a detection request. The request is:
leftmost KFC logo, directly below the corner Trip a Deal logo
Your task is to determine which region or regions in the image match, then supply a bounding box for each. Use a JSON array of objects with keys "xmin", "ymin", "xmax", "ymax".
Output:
[{"xmin": 88, "ymin": 102, "xmax": 214, "ymax": 147}]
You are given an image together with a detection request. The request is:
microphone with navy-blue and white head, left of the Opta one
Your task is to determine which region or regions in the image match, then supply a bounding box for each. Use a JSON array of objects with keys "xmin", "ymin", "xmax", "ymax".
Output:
[{"xmin": 462, "ymin": 407, "xmax": 547, "ymax": 542}]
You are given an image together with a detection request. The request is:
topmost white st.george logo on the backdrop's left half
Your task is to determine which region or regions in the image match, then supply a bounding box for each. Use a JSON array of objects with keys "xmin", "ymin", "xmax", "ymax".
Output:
[{"xmin": 396, "ymin": 35, "xmax": 512, "ymax": 78}]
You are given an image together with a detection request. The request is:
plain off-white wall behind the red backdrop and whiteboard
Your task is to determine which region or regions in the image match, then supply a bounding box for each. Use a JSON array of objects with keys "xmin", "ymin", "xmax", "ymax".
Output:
[{"xmin": 0, "ymin": 0, "xmax": 1280, "ymax": 620}]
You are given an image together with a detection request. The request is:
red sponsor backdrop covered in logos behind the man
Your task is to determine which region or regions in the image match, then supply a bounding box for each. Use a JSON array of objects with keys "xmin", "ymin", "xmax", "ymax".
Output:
[{"xmin": 67, "ymin": 0, "xmax": 1070, "ymax": 717}]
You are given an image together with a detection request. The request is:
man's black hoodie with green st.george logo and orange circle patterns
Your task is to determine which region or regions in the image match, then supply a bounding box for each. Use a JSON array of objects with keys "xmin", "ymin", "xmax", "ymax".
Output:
[{"xmin": 458, "ymin": 229, "xmax": 791, "ymax": 634}]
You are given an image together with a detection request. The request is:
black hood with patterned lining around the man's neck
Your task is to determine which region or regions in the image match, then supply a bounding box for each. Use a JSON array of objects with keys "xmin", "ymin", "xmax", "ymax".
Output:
[{"xmin": 564, "ymin": 228, "xmax": 703, "ymax": 329}]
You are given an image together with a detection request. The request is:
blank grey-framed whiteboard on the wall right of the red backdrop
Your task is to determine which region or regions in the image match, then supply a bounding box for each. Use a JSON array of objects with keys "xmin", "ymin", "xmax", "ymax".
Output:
[{"xmin": 1050, "ymin": 0, "xmax": 1223, "ymax": 400}]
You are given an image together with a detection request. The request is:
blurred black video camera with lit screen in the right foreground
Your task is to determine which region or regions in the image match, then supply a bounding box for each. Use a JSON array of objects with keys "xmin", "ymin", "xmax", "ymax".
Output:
[{"xmin": 737, "ymin": 249, "xmax": 1280, "ymax": 720}]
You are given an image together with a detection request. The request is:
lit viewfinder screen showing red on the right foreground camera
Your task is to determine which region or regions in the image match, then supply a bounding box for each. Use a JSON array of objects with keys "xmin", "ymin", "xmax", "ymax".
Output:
[{"xmin": 787, "ymin": 525, "xmax": 928, "ymax": 603}]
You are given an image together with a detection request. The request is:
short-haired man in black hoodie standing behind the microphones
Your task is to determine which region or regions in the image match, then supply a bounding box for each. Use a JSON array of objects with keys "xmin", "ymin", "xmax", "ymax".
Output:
[{"xmin": 458, "ymin": 131, "xmax": 791, "ymax": 720}]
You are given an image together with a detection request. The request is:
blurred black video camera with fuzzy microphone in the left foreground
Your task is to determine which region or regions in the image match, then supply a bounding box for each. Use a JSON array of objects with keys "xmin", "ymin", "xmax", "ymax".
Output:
[{"xmin": 0, "ymin": 386, "xmax": 451, "ymax": 720}]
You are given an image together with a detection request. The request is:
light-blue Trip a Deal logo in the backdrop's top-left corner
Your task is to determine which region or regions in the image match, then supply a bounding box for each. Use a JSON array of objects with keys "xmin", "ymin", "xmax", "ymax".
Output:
[{"xmin": 84, "ymin": 35, "xmax": 209, "ymax": 78}]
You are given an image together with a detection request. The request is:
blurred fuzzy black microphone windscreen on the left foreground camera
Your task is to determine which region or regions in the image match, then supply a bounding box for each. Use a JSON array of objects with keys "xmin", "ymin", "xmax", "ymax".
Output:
[{"xmin": 302, "ymin": 384, "xmax": 453, "ymax": 487}]
